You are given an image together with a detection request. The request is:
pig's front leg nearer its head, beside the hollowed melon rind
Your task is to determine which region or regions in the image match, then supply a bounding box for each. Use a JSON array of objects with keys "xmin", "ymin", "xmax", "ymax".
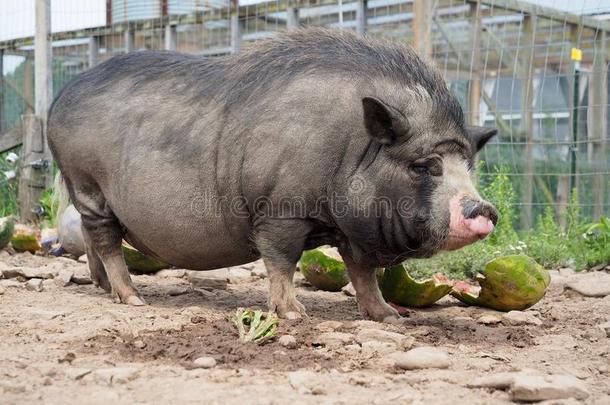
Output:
[{"xmin": 342, "ymin": 254, "xmax": 400, "ymax": 323}]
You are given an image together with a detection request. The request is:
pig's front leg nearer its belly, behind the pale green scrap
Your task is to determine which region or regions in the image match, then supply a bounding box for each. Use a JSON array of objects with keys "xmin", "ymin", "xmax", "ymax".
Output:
[{"xmin": 256, "ymin": 220, "xmax": 311, "ymax": 318}]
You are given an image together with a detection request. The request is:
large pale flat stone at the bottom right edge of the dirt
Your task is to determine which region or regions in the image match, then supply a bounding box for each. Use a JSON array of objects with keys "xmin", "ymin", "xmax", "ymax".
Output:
[{"xmin": 511, "ymin": 375, "xmax": 589, "ymax": 402}]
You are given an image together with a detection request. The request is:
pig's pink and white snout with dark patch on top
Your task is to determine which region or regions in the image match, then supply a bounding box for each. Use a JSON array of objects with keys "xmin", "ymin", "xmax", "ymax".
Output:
[{"xmin": 445, "ymin": 196, "xmax": 498, "ymax": 250}]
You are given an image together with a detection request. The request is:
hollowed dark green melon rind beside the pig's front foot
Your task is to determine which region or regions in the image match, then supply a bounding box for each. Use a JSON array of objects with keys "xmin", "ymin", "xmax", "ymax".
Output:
[{"xmin": 379, "ymin": 265, "xmax": 452, "ymax": 308}]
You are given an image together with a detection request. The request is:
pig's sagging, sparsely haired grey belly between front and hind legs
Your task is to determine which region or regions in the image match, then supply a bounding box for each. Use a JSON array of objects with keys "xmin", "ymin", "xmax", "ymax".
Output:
[{"xmin": 105, "ymin": 161, "xmax": 258, "ymax": 270}]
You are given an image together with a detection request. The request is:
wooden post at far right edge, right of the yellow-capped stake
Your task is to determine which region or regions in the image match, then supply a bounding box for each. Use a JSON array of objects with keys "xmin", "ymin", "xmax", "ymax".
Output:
[{"xmin": 587, "ymin": 31, "xmax": 608, "ymax": 219}]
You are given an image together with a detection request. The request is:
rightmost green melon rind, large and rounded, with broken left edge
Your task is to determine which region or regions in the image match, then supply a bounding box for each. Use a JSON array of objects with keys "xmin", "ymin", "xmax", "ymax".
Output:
[{"xmin": 451, "ymin": 255, "xmax": 551, "ymax": 312}]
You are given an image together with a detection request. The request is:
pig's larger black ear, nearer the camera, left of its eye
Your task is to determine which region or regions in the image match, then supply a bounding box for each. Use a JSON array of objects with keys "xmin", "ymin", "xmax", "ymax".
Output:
[{"xmin": 362, "ymin": 97, "xmax": 409, "ymax": 145}]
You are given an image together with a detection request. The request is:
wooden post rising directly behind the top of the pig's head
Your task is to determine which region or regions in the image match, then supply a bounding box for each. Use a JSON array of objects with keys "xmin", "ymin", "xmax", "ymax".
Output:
[{"xmin": 468, "ymin": 2, "xmax": 481, "ymax": 125}]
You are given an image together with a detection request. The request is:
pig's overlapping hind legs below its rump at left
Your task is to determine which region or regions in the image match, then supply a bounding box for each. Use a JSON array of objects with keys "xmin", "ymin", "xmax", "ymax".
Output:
[{"xmin": 68, "ymin": 175, "xmax": 146, "ymax": 305}]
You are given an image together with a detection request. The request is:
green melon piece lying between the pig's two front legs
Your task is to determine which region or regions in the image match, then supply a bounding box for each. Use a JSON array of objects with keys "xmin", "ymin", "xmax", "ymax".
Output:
[{"xmin": 299, "ymin": 249, "xmax": 349, "ymax": 291}]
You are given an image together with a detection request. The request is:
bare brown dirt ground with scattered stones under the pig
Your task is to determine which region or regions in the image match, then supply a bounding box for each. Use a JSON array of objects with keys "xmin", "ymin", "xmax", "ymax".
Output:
[{"xmin": 0, "ymin": 251, "xmax": 610, "ymax": 404}]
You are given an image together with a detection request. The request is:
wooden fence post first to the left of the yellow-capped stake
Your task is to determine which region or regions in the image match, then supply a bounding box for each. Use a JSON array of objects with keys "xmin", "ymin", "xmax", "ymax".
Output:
[{"xmin": 519, "ymin": 15, "xmax": 537, "ymax": 231}]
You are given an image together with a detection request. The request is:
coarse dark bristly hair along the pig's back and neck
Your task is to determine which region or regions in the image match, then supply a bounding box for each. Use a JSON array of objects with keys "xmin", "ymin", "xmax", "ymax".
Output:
[{"xmin": 55, "ymin": 28, "xmax": 463, "ymax": 123}]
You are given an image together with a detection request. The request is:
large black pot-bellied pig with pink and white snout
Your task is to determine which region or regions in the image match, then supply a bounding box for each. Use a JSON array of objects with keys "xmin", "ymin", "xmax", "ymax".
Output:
[{"xmin": 48, "ymin": 29, "xmax": 497, "ymax": 320}]
